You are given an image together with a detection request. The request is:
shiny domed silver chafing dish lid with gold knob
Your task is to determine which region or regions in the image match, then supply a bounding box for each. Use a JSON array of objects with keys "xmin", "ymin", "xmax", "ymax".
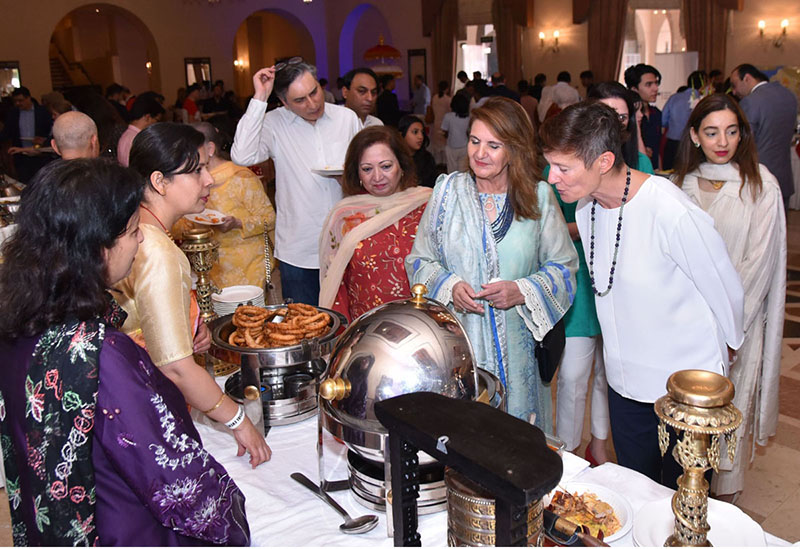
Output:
[{"xmin": 320, "ymin": 284, "xmax": 477, "ymax": 432}]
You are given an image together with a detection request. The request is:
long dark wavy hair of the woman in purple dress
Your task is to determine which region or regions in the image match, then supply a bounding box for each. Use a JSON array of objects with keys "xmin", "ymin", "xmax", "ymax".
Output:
[{"xmin": 0, "ymin": 159, "xmax": 144, "ymax": 339}]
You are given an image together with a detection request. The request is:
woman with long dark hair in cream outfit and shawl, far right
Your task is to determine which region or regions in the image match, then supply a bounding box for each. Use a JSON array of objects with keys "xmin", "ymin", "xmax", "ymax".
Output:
[{"xmin": 675, "ymin": 94, "xmax": 786, "ymax": 499}]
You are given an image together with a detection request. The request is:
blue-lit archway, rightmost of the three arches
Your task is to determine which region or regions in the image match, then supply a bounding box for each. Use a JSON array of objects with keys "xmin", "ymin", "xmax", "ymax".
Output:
[{"xmin": 339, "ymin": 4, "xmax": 393, "ymax": 75}]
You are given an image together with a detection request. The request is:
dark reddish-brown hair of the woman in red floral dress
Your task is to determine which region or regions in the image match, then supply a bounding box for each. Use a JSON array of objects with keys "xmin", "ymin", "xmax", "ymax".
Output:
[{"xmin": 342, "ymin": 126, "xmax": 417, "ymax": 196}]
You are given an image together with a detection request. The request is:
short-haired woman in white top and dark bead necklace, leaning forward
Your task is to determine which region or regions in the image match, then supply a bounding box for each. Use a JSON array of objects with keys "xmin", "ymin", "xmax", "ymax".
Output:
[{"xmin": 540, "ymin": 103, "xmax": 744, "ymax": 488}]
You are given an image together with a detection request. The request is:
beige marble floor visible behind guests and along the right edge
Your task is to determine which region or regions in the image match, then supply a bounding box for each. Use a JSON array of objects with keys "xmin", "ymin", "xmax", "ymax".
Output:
[{"xmin": 0, "ymin": 211, "xmax": 800, "ymax": 546}]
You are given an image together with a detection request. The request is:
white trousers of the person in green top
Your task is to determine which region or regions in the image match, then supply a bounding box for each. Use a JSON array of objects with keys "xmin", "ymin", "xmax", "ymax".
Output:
[{"xmin": 556, "ymin": 336, "xmax": 610, "ymax": 451}]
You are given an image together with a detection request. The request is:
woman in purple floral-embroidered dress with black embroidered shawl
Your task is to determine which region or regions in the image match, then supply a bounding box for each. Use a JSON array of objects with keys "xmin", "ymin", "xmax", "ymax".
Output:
[{"xmin": 0, "ymin": 160, "xmax": 250, "ymax": 546}]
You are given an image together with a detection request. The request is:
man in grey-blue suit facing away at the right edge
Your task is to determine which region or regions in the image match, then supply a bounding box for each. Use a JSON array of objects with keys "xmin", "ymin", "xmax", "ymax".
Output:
[{"xmin": 731, "ymin": 63, "xmax": 797, "ymax": 204}]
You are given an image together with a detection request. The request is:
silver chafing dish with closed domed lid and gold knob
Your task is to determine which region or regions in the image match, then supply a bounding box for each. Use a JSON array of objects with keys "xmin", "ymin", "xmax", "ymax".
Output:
[{"xmin": 318, "ymin": 284, "xmax": 505, "ymax": 523}]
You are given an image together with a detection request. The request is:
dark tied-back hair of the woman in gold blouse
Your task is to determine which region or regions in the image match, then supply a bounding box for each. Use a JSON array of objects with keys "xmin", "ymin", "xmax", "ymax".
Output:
[{"xmin": 129, "ymin": 122, "xmax": 205, "ymax": 188}]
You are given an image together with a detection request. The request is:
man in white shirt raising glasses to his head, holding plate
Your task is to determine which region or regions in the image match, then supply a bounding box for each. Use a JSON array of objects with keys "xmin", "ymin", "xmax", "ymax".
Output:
[{"xmin": 231, "ymin": 58, "xmax": 361, "ymax": 305}]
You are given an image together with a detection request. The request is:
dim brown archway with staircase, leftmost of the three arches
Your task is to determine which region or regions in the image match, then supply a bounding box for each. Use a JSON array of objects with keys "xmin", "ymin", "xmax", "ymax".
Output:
[{"xmin": 49, "ymin": 4, "xmax": 161, "ymax": 93}]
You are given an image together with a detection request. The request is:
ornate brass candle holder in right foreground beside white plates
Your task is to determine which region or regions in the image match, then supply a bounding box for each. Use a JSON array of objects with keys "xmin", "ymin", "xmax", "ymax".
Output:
[{"xmin": 655, "ymin": 370, "xmax": 742, "ymax": 547}]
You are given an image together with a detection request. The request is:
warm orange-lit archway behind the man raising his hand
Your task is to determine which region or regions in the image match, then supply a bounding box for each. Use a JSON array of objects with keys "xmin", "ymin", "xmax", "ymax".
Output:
[{"xmin": 233, "ymin": 9, "xmax": 317, "ymax": 97}]
